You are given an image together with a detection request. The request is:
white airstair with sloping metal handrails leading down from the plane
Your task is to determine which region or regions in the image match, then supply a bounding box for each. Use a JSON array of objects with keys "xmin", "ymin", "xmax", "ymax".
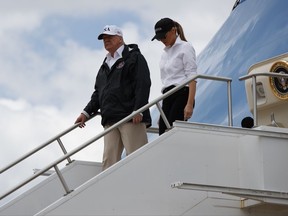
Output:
[{"xmin": 0, "ymin": 74, "xmax": 288, "ymax": 216}]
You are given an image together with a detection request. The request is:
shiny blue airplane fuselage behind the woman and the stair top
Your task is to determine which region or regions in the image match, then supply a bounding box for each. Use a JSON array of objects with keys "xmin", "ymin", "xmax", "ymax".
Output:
[{"xmin": 192, "ymin": 0, "xmax": 288, "ymax": 126}]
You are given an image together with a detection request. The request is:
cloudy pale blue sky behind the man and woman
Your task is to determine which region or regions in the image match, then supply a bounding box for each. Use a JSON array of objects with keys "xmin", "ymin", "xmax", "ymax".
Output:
[{"xmin": 0, "ymin": 0, "xmax": 235, "ymax": 202}]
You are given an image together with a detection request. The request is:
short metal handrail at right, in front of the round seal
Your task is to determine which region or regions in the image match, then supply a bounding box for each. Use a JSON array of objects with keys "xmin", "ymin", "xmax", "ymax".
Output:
[{"xmin": 239, "ymin": 72, "xmax": 288, "ymax": 127}]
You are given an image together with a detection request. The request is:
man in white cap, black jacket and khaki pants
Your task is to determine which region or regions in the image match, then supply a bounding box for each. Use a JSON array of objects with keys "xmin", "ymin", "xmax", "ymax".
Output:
[{"xmin": 75, "ymin": 25, "xmax": 151, "ymax": 170}]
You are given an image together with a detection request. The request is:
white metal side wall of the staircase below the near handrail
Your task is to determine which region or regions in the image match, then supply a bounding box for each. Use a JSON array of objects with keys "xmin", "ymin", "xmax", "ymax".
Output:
[{"xmin": 32, "ymin": 122, "xmax": 288, "ymax": 216}]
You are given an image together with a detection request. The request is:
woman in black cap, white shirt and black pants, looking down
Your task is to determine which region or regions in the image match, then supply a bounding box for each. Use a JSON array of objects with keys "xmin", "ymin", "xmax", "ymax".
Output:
[{"xmin": 152, "ymin": 18, "xmax": 197, "ymax": 135}]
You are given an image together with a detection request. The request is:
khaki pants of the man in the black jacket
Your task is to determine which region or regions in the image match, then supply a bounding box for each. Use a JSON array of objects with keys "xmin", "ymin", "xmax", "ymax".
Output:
[{"xmin": 102, "ymin": 122, "xmax": 148, "ymax": 170}]
